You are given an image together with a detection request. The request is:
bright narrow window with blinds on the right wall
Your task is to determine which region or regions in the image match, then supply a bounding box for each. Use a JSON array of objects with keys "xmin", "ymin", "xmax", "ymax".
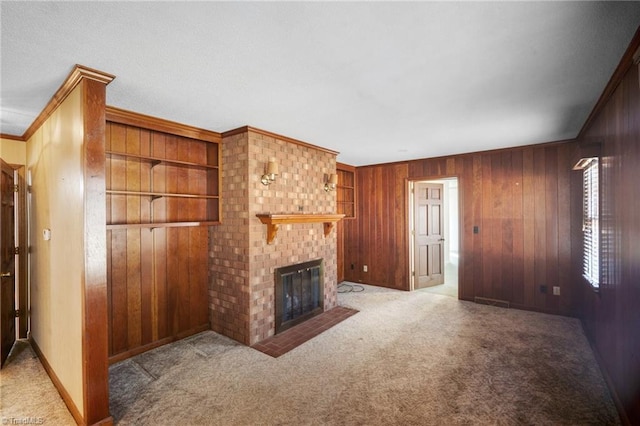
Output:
[{"xmin": 582, "ymin": 158, "xmax": 600, "ymax": 288}]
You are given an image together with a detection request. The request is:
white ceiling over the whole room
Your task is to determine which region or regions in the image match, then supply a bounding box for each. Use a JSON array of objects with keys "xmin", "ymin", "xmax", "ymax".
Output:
[{"xmin": 0, "ymin": 0, "xmax": 640, "ymax": 165}]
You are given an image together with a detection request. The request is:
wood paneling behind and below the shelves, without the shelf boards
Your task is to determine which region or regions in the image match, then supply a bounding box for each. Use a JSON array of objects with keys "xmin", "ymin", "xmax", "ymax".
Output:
[{"xmin": 106, "ymin": 122, "xmax": 209, "ymax": 362}]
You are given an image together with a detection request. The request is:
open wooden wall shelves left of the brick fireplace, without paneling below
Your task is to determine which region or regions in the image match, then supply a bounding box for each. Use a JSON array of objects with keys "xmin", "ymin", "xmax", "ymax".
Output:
[{"xmin": 106, "ymin": 134, "xmax": 220, "ymax": 229}]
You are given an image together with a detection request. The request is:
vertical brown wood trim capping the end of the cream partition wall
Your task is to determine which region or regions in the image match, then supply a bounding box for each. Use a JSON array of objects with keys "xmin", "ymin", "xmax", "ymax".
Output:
[{"xmin": 82, "ymin": 79, "xmax": 112, "ymax": 424}]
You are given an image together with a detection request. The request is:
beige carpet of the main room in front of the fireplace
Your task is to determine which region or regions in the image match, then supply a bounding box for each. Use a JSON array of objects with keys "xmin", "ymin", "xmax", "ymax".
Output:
[{"xmin": 3, "ymin": 286, "xmax": 619, "ymax": 425}]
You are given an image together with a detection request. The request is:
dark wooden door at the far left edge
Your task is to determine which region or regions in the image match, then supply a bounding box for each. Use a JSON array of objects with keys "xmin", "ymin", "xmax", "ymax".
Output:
[{"xmin": 0, "ymin": 160, "xmax": 16, "ymax": 366}]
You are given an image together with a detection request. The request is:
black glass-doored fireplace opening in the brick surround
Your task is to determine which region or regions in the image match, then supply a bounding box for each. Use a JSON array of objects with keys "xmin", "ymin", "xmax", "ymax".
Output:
[{"xmin": 275, "ymin": 259, "xmax": 324, "ymax": 334}]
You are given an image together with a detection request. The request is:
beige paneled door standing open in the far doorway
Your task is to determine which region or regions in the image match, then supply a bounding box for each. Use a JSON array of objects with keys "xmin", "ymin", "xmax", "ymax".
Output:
[{"xmin": 413, "ymin": 182, "xmax": 444, "ymax": 289}]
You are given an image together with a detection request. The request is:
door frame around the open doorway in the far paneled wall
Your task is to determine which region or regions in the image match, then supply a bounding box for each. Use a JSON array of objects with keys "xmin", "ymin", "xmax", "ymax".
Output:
[{"xmin": 406, "ymin": 175, "xmax": 464, "ymax": 294}]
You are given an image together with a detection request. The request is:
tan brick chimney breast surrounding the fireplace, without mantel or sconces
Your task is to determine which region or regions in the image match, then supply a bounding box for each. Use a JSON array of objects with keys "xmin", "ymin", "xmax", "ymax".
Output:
[{"xmin": 209, "ymin": 127, "xmax": 337, "ymax": 345}]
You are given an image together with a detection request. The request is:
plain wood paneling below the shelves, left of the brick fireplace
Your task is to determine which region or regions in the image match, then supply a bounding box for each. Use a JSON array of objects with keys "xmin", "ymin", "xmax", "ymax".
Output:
[{"xmin": 107, "ymin": 227, "xmax": 209, "ymax": 361}]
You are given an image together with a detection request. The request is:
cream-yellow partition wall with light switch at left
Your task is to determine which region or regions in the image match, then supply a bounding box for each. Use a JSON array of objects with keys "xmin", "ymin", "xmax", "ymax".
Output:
[{"xmin": 26, "ymin": 86, "xmax": 85, "ymax": 416}]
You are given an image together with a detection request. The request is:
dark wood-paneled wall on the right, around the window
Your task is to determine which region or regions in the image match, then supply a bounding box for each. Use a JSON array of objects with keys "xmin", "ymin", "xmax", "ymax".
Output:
[{"xmin": 573, "ymin": 29, "xmax": 640, "ymax": 424}]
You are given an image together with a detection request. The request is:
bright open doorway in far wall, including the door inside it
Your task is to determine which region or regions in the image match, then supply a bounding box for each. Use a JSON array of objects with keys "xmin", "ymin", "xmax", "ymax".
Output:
[{"xmin": 409, "ymin": 177, "xmax": 460, "ymax": 298}]
